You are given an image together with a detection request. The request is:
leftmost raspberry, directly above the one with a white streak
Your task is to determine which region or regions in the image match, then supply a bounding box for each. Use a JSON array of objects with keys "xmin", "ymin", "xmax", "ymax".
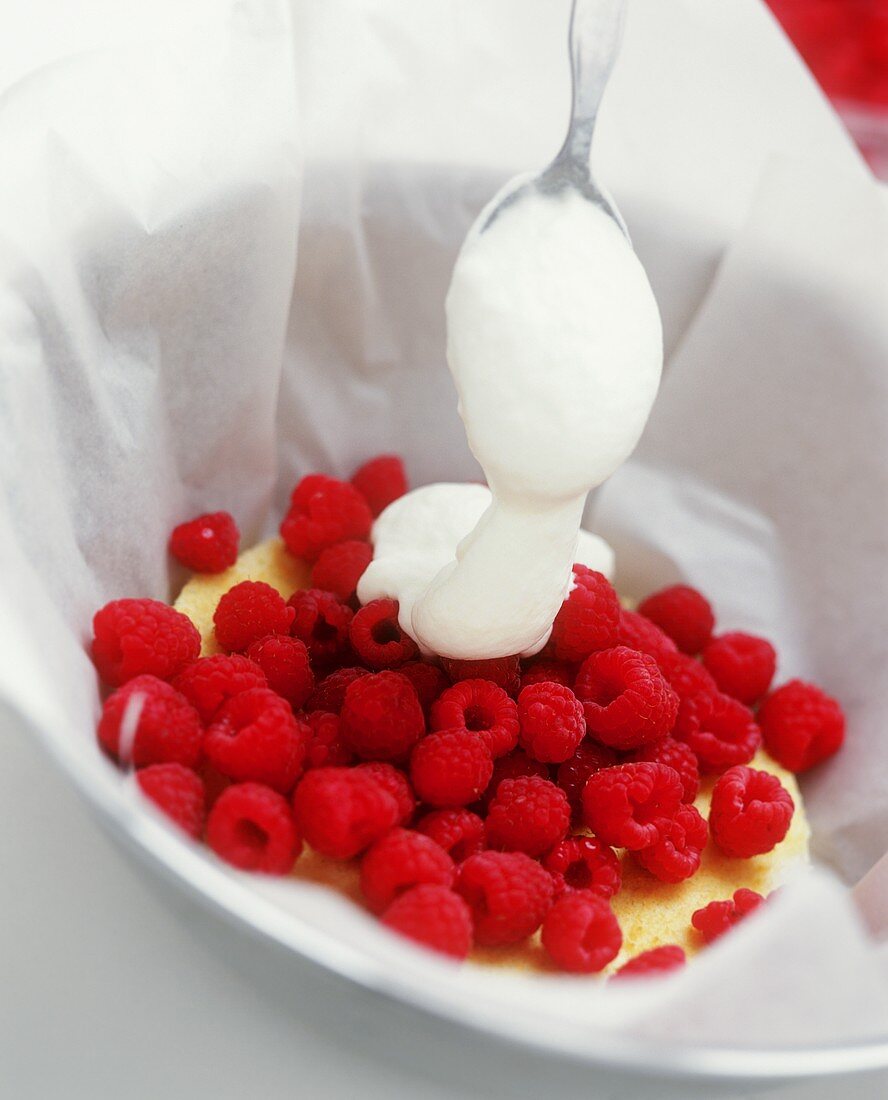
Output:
[{"xmin": 92, "ymin": 600, "xmax": 200, "ymax": 688}]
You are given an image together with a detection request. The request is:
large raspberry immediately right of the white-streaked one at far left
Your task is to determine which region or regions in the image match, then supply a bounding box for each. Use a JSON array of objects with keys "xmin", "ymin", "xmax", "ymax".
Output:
[{"xmin": 204, "ymin": 688, "xmax": 311, "ymax": 794}]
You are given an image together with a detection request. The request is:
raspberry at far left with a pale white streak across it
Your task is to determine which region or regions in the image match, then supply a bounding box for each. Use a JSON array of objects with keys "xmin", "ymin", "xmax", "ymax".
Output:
[{"xmin": 98, "ymin": 677, "xmax": 202, "ymax": 768}]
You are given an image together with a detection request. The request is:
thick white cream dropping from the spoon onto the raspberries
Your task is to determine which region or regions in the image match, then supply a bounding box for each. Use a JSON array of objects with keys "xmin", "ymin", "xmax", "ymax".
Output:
[{"xmin": 358, "ymin": 184, "xmax": 662, "ymax": 659}]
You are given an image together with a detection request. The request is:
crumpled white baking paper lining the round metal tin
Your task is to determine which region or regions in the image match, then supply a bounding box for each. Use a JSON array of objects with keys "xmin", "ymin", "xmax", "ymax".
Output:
[{"xmin": 0, "ymin": 0, "xmax": 888, "ymax": 1047}]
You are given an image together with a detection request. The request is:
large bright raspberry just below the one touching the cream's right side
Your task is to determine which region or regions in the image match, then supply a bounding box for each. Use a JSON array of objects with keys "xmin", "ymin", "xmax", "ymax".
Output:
[{"xmin": 573, "ymin": 646, "xmax": 678, "ymax": 749}]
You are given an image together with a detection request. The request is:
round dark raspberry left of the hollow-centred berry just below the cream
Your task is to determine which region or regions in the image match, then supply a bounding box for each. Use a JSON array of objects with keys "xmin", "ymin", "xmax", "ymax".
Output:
[{"xmin": 339, "ymin": 672, "xmax": 426, "ymax": 760}]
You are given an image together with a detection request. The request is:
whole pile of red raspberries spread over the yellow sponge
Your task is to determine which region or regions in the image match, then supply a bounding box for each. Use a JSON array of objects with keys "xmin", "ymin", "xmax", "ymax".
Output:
[{"xmin": 92, "ymin": 455, "xmax": 844, "ymax": 975}]
